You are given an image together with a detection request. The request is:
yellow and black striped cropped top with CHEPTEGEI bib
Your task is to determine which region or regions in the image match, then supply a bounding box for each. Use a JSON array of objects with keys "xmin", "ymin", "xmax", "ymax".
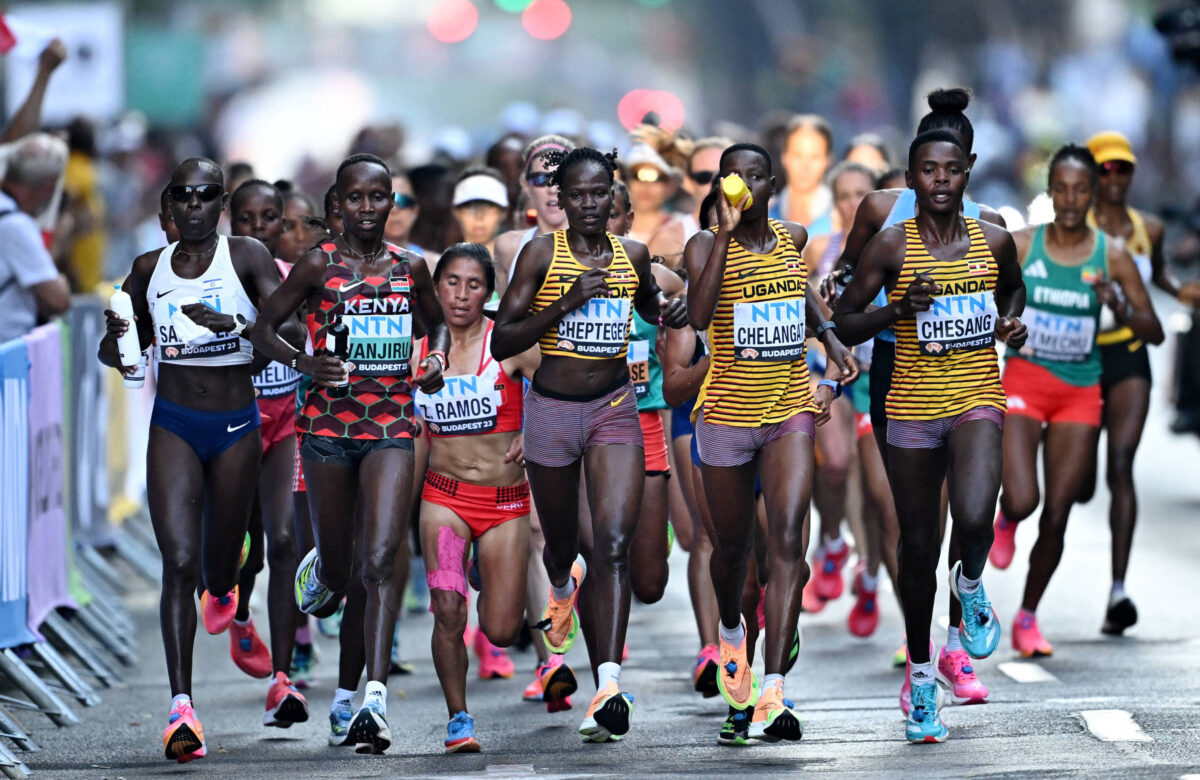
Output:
[{"xmin": 529, "ymin": 229, "xmax": 638, "ymax": 360}]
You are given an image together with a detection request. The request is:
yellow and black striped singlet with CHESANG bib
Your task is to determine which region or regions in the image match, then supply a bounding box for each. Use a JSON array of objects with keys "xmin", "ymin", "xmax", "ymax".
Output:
[{"xmin": 887, "ymin": 217, "xmax": 1006, "ymax": 420}]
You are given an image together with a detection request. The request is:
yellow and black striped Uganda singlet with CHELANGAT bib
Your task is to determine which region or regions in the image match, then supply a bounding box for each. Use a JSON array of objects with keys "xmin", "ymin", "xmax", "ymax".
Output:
[{"xmin": 692, "ymin": 220, "xmax": 817, "ymax": 427}]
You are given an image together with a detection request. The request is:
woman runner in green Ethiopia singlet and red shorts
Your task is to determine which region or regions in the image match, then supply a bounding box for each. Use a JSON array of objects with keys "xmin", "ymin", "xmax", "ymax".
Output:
[{"xmin": 990, "ymin": 144, "xmax": 1163, "ymax": 658}]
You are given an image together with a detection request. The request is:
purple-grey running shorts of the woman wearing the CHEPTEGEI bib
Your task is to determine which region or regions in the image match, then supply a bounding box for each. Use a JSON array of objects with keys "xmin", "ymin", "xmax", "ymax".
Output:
[{"xmin": 524, "ymin": 373, "xmax": 644, "ymax": 468}]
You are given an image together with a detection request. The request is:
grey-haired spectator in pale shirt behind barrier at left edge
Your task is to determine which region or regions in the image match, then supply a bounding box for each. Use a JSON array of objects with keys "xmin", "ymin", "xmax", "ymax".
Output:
[{"xmin": 0, "ymin": 133, "xmax": 71, "ymax": 340}]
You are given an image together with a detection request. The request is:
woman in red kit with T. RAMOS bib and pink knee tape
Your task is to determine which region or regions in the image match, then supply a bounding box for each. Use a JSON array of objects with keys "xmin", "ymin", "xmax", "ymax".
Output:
[{"xmin": 414, "ymin": 244, "xmax": 542, "ymax": 752}]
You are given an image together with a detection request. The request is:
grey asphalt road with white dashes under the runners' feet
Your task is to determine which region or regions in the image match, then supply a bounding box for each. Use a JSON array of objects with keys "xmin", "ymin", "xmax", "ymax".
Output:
[{"xmin": 16, "ymin": 360, "xmax": 1200, "ymax": 779}]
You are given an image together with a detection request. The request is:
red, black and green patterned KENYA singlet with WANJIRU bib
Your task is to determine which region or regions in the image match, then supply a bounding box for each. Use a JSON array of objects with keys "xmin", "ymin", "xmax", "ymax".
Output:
[{"xmin": 296, "ymin": 242, "xmax": 416, "ymax": 439}]
